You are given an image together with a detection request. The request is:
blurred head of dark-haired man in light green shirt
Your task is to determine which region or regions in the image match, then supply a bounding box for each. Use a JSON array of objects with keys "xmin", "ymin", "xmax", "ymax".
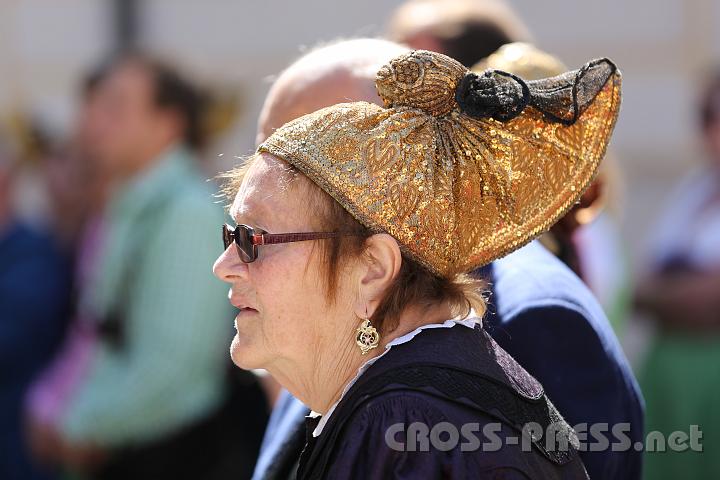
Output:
[{"xmin": 86, "ymin": 54, "xmax": 208, "ymax": 174}]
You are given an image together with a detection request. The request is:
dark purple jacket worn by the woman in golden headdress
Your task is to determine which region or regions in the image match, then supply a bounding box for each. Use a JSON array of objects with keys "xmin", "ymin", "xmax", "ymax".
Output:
[{"xmin": 297, "ymin": 324, "xmax": 588, "ymax": 480}]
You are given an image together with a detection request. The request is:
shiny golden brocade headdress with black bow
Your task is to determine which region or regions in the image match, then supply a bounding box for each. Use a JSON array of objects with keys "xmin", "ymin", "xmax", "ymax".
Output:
[{"xmin": 258, "ymin": 50, "xmax": 620, "ymax": 277}]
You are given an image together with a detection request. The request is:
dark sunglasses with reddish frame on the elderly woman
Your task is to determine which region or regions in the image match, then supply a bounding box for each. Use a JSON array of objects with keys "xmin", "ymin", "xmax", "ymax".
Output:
[{"xmin": 223, "ymin": 223, "xmax": 356, "ymax": 263}]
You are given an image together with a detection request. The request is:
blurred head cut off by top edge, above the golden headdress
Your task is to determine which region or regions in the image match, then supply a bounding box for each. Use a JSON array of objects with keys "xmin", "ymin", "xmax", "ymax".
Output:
[{"xmin": 388, "ymin": 0, "xmax": 530, "ymax": 68}]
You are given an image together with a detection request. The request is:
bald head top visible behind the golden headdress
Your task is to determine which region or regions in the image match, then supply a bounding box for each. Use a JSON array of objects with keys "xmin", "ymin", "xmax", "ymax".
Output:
[{"xmin": 256, "ymin": 38, "xmax": 408, "ymax": 144}]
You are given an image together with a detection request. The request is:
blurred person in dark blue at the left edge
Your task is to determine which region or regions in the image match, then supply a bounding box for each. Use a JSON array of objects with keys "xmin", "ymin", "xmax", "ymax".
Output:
[{"xmin": 0, "ymin": 132, "xmax": 71, "ymax": 480}]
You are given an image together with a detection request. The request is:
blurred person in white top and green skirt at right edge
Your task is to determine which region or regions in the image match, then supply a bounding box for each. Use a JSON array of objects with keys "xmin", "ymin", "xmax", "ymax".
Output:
[{"xmin": 635, "ymin": 72, "xmax": 720, "ymax": 480}]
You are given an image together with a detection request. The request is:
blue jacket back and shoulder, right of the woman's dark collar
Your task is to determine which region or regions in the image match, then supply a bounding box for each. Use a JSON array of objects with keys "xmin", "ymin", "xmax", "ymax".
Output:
[{"xmin": 484, "ymin": 242, "xmax": 644, "ymax": 480}]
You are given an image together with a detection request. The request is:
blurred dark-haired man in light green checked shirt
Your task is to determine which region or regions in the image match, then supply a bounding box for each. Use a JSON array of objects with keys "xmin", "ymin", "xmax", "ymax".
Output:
[{"xmin": 26, "ymin": 53, "xmax": 267, "ymax": 479}]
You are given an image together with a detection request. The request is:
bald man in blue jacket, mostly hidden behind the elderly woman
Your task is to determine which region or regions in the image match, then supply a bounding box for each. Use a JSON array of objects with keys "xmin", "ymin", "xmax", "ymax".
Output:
[{"xmin": 254, "ymin": 39, "xmax": 643, "ymax": 480}]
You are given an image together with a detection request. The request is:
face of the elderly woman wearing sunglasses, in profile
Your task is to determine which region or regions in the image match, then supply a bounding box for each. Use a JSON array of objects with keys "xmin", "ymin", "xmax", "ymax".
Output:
[{"xmin": 213, "ymin": 154, "xmax": 352, "ymax": 371}]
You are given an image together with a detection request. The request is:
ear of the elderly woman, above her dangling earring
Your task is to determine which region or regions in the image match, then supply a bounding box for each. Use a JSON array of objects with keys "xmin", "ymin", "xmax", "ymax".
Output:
[{"xmin": 355, "ymin": 233, "xmax": 402, "ymax": 318}]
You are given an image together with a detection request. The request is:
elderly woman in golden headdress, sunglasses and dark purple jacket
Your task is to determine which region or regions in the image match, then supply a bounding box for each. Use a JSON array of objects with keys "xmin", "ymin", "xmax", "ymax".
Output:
[{"xmin": 214, "ymin": 51, "xmax": 620, "ymax": 479}]
